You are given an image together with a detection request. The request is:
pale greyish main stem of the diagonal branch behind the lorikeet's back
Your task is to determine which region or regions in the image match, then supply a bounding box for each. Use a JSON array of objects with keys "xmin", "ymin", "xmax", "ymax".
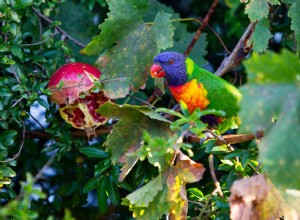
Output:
[{"xmin": 215, "ymin": 22, "xmax": 256, "ymax": 76}]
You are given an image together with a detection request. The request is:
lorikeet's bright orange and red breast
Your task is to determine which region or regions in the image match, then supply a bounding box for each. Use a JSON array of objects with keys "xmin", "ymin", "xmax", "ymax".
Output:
[{"xmin": 169, "ymin": 79, "xmax": 209, "ymax": 113}]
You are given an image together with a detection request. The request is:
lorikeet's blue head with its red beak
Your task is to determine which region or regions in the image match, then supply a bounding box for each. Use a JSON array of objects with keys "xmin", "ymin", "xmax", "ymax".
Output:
[{"xmin": 150, "ymin": 52, "xmax": 188, "ymax": 86}]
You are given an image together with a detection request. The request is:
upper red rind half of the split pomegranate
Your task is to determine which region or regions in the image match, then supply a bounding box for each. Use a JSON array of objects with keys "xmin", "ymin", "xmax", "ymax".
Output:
[{"xmin": 48, "ymin": 62, "xmax": 101, "ymax": 104}]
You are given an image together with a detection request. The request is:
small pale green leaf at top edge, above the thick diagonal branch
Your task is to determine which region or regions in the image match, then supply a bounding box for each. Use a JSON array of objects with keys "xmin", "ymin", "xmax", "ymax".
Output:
[{"xmin": 245, "ymin": 0, "xmax": 269, "ymax": 22}]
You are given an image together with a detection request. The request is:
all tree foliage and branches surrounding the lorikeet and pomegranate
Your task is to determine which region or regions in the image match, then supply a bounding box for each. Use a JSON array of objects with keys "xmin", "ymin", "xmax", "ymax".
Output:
[{"xmin": 0, "ymin": 0, "xmax": 300, "ymax": 219}]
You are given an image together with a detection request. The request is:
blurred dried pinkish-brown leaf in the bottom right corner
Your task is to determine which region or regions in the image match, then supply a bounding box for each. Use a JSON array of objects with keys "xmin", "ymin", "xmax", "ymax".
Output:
[{"xmin": 229, "ymin": 175, "xmax": 285, "ymax": 220}]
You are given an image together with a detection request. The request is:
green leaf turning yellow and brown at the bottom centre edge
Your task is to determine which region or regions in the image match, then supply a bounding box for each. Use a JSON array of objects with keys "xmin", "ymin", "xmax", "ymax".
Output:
[{"xmin": 122, "ymin": 152, "xmax": 205, "ymax": 219}]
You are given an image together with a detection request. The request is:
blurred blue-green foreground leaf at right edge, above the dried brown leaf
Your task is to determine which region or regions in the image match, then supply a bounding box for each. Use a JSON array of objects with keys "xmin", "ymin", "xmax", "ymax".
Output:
[{"xmin": 259, "ymin": 95, "xmax": 300, "ymax": 190}]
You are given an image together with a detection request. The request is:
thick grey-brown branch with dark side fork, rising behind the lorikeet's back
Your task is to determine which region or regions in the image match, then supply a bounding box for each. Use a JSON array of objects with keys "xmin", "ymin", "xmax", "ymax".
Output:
[{"xmin": 215, "ymin": 22, "xmax": 257, "ymax": 76}]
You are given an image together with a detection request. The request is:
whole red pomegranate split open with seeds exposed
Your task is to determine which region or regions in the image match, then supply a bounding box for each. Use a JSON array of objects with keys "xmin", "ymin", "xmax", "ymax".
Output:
[{"xmin": 48, "ymin": 62, "xmax": 110, "ymax": 135}]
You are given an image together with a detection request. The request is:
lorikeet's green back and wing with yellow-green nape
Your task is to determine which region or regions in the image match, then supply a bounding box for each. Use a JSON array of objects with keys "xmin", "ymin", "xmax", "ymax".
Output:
[{"xmin": 186, "ymin": 58, "xmax": 242, "ymax": 117}]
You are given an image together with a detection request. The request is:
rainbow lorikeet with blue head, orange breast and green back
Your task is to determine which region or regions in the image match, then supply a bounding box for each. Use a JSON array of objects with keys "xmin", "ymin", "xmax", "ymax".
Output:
[{"xmin": 150, "ymin": 52, "xmax": 241, "ymax": 126}]
